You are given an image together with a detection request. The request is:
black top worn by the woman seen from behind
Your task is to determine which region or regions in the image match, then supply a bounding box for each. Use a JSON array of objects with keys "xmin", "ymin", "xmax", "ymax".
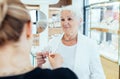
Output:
[{"xmin": 0, "ymin": 68, "xmax": 78, "ymax": 79}]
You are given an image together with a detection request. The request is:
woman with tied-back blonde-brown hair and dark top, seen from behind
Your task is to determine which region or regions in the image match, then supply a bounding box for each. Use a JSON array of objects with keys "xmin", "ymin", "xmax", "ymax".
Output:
[{"xmin": 0, "ymin": 0, "xmax": 77, "ymax": 79}]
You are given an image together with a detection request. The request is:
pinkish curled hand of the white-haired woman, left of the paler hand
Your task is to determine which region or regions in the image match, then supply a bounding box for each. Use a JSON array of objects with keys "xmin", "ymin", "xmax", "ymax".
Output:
[{"xmin": 36, "ymin": 52, "xmax": 49, "ymax": 67}]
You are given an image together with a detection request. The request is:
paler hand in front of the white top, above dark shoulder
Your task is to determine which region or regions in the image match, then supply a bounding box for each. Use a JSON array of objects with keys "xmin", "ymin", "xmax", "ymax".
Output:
[{"xmin": 48, "ymin": 53, "xmax": 63, "ymax": 69}]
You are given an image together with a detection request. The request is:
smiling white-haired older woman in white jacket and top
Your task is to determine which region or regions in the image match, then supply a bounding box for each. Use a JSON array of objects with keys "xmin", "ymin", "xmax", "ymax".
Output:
[{"xmin": 37, "ymin": 7, "xmax": 105, "ymax": 79}]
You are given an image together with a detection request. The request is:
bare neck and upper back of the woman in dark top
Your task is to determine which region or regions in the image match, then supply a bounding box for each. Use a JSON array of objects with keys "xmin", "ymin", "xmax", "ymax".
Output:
[{"xmin": 0, "ymin": 45, "xmax": 32, "ymax": 76}]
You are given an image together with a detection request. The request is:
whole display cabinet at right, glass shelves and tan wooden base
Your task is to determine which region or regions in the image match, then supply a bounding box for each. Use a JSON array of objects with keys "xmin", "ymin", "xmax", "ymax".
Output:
[{"xmin": 84, "ymin": 0, "xmax": 120, "ymax": 79}]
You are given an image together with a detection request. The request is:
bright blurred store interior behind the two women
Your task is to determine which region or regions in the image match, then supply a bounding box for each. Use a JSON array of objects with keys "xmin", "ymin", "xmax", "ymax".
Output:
[{"xmin": 21, "ymin": 0, "xmax": 120, "ymax": 79}]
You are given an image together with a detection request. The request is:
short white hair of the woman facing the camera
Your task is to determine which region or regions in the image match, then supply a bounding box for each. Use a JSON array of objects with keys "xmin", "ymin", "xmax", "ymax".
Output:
[{"xmin": 61, "ymin": 6, "xmax": 82, "ymax": 19}]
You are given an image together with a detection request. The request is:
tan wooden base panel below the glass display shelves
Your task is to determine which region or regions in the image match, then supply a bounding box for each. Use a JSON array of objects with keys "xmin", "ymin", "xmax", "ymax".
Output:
[{"xmin": 101, "ymin": 56, "xmax": 119, "ymax": 79}]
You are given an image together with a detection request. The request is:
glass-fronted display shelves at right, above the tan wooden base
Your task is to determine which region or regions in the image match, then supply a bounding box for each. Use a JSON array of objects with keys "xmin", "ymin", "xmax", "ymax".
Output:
[{"xmin": 85, "ymin": 2, "xmax": 120, "ymax": 63}]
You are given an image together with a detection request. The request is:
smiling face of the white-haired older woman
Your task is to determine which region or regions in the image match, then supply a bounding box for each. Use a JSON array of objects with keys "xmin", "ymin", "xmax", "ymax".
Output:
[{"xmin": 61, "ymin": 10, "xmax": 79, "ymax": 34}]
